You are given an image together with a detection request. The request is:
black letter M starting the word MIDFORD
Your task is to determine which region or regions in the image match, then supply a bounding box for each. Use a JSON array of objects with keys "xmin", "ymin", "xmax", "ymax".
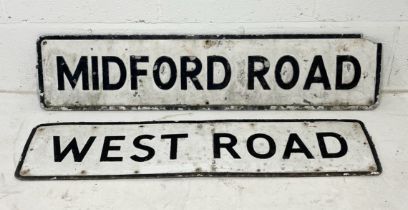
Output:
[{"xmin": 57, "ymin": 56, "xmax": 89, "ymax": 90}]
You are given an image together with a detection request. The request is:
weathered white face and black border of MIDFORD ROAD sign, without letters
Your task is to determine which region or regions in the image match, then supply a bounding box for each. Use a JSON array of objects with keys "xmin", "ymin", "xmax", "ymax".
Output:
[{"xmin": 38, "ymin": 34, "xmax": 381, "ymax": 110}]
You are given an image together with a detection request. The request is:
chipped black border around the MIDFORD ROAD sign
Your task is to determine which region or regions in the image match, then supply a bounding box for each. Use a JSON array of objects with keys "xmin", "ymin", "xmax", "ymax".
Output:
[{"xmin": 37, "ymin": 34, "xmax": 382, "ymax": 111}]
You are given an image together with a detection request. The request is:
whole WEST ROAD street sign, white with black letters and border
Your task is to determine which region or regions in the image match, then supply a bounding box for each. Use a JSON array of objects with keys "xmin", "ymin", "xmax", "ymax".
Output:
[{"xmin": 15, "ymin": 120, "xmax": 381, "ymax": 180}]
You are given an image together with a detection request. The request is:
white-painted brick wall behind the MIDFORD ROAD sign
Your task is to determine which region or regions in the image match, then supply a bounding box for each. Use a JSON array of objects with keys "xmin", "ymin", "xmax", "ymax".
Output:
[{"xmin": 0, "ymin": 0, "xmax": 408, "ymax": 91}]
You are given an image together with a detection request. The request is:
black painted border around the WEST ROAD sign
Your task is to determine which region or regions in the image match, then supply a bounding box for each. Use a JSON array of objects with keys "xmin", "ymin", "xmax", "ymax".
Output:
[{"xmin": 14, "ymin": 119, "xmax": 382, "ymax": 180}]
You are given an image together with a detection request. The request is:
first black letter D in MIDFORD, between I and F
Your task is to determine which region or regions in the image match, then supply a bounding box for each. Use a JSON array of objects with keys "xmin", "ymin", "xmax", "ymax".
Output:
[{"xmin": 102, "ymin": 56, "xmax": 126, "ymax": 90}]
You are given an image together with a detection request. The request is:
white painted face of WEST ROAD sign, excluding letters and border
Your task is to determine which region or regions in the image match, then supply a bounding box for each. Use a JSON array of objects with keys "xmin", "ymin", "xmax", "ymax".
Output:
[{"xmin": 20, "ymin": 121, "xmax": 377, "ymax": 177}]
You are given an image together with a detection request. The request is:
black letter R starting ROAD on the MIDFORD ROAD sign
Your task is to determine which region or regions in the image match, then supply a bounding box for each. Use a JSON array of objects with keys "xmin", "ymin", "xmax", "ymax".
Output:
[{"xmin": 248, "ymin": 56, "xmax": 271, "ymax": 90}]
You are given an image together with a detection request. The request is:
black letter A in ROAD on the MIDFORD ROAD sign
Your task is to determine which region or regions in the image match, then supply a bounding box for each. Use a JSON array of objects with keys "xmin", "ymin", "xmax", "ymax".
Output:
[{"xmin": 303, "ymin": 55, "xmax": 331, "ymax": 90}]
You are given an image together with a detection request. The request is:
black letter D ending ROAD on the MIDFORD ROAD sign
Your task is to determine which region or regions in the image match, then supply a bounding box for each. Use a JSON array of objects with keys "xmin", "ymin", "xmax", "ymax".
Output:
[{"xmin": 336, "ymin": 55, "xmax": 361, "ymax": 90}]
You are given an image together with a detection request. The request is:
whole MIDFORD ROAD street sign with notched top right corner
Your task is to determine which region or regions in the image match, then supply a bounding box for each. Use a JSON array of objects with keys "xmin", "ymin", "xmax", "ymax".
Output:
[{"xmin": 38, "ymin": 34, "xmax": 381, "ymax": 110}]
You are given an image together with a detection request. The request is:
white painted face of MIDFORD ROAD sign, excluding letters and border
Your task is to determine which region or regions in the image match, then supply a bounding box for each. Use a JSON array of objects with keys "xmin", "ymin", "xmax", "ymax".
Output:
[{"xmin": 41, "ymin": 39, "xmax": 377, "ymax": 109}]
